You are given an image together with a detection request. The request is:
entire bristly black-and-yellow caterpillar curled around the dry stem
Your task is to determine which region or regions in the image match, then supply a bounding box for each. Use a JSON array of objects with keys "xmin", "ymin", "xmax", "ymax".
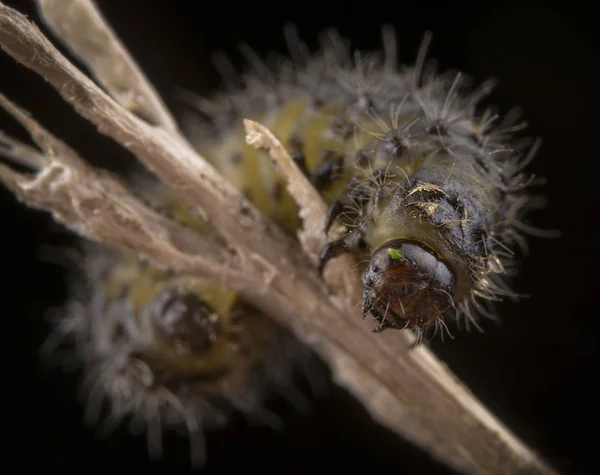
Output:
[{"xmin": 0, "ymin": 17, "xmax": 537, "ymax": 464}]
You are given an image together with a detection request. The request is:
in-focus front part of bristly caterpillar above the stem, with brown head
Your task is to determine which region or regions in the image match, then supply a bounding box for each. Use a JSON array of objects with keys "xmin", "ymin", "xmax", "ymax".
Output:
[{"xmin": 186, "ymin": 29, "xmax": 538, "ymax": 342}]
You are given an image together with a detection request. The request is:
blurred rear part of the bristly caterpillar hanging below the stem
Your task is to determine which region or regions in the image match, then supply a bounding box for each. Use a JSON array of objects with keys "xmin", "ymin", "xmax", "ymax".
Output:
[{"xmin": 37, "ymin": 177, "xmax": 326, "ymax": 467}]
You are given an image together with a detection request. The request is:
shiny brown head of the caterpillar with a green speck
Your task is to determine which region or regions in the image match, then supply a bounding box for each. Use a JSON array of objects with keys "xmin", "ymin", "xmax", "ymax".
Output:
[{"xmin": 362, "ymin": 239, "xmax": 455, "ymax": 330}]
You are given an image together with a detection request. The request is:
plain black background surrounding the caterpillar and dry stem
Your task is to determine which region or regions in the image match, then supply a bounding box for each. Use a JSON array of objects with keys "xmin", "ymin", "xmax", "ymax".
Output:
[{"xmin": 0, "ymin": 0, "xmax": 600, "ymax": 474}]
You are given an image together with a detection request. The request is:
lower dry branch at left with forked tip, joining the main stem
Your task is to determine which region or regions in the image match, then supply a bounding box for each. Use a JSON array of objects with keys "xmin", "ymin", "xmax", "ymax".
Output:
[{"xmin": 0, "ymin": 94, "xmax": 248, "ymax": 286}]
